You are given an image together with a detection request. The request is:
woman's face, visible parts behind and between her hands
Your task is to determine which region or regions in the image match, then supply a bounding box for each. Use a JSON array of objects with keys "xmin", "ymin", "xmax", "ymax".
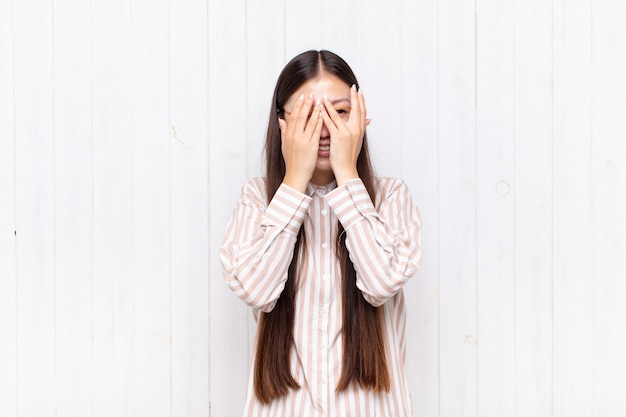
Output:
[{"xmin": 284, "ymin": 73, "xmax": 351, "ymax": 185}]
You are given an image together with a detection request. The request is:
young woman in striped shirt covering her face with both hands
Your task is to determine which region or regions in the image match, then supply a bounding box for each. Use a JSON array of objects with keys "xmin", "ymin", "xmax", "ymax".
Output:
[{"xmin": 220, "ymin": 51, "xmax": 421, "ymax": 417}]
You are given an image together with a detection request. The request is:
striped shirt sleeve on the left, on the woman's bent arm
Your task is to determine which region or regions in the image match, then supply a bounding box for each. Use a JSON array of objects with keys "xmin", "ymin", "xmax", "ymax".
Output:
[{"xmin": 220, "ymin": 178, "xmax": 311, "ymax": 312}]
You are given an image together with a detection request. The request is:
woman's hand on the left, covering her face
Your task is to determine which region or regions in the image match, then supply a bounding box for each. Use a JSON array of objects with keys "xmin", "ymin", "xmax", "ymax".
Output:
[{"xmin": 278, "ymin": 94, "xmax": 324, "ymax": 193}]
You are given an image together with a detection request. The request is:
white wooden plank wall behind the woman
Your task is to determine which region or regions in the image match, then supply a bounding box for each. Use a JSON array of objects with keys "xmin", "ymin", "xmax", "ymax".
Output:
[{"xmin": 0, "ymin": 0, "xmax": 626, "ymax": 417}]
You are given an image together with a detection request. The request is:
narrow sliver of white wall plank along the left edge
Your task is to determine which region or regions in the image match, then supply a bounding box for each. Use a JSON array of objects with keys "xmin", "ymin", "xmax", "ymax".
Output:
[{"xmin": 0, "ymin": 1, "xmax": 17, "ymax": 416}]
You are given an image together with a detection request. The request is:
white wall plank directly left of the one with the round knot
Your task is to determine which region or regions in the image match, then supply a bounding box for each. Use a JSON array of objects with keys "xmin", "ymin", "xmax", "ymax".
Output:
[{"xmin": 438, "ymin": 0, "xmax": 476, "ymax": 417}]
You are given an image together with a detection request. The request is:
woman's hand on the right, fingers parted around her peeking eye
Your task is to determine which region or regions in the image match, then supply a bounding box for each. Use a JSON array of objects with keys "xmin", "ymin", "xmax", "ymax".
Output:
[{"xmin": 322, "ymin": 85, "xmax": 370, "ymax": 185}]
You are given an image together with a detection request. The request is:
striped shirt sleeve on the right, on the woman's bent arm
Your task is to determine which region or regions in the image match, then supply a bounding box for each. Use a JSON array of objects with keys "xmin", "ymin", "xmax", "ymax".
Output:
[{"xmin": 326, "ymin": 178, "xmax": 422, "ymax": 306}]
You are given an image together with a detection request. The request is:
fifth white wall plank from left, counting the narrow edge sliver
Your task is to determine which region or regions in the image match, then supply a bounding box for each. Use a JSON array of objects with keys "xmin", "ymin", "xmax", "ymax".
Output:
[{"xmin": 131, "ymin": 0, "xmax": 171, "ymax": 417}]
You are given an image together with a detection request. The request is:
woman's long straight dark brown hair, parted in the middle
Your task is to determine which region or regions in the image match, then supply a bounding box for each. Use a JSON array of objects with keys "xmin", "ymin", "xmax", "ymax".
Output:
[{"xmin": 254, "ymin": 51, "xmax": 390, "ymax": 403}]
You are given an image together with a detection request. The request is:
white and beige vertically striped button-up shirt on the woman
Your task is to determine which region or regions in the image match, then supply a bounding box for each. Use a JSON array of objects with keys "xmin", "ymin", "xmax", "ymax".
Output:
[{"xmin": 220, "ymin": 178, "xmax": 421, "ymax": 417}]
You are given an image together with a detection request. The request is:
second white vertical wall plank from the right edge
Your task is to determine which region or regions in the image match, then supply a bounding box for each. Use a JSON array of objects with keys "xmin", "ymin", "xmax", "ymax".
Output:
[{"xmin": 553, "ymin": 0, "xmax": 594, "ymax": 417}]
